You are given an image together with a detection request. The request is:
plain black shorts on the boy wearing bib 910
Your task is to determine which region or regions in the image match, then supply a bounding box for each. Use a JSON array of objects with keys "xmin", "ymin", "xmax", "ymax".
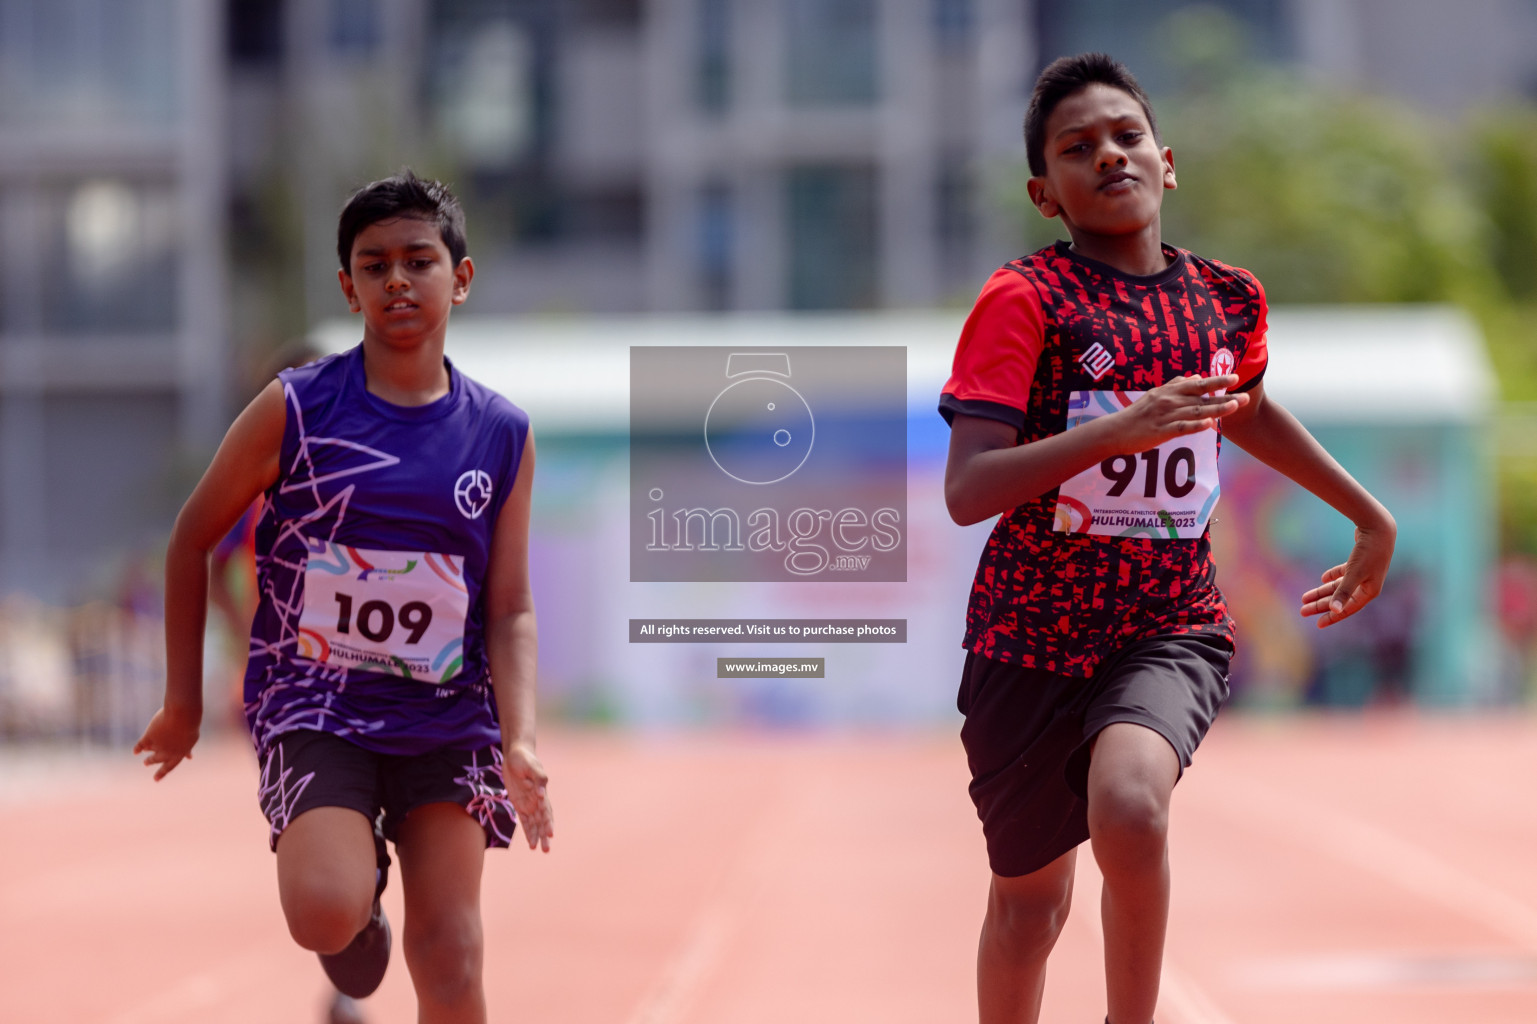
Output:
[{"xmin": 956, "ymin": 633, "xmax": 1233, "ymax": 878}]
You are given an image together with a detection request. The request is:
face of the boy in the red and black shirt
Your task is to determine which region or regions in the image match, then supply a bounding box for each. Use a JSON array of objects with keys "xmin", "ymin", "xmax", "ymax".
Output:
[{"xmin": 1030, "ymin": 81, "xmax": 1174, "ymax": 240}]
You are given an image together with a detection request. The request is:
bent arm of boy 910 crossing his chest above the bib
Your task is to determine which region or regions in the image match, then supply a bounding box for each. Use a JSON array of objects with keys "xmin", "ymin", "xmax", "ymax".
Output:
[{"xmin": 945, "ymin": 374, "xmax": 1248, "ymax": 526}]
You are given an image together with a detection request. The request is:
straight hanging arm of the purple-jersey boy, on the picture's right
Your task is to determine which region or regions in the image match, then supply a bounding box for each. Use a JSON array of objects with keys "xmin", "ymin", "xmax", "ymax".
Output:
[{"xmin": 486, "ymin": 432, "xmax": 555, "ymax": 853}]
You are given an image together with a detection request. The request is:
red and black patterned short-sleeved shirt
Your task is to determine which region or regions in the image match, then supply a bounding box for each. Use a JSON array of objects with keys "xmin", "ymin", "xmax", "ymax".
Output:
[{"xmin": 939, "ymin": 241, "xmax": 1266, "ymax": 677}]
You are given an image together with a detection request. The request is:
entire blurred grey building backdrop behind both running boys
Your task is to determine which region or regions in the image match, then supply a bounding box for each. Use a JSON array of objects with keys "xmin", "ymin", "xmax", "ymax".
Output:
[{"xmin": 0, "ymin": 0, "xmax": 1537, "ymax": 600}]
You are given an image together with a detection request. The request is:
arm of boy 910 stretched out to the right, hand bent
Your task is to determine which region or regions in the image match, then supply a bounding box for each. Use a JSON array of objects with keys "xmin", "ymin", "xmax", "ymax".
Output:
[{"xmin": 1222, "ymin": 380, "xmax": 1399, "ymax": 629}]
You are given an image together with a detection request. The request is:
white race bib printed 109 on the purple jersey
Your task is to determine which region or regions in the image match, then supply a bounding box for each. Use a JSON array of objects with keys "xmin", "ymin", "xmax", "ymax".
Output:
[{"xmin": 298, "ymin": 538, "xmax": 469, "ymax": 684}]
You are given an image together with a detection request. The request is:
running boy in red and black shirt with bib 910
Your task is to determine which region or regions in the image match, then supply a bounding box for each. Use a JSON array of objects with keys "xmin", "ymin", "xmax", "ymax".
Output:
[{"xmin": 941, "ymin": 54, "xmax": 1396, "ymax": 1024}]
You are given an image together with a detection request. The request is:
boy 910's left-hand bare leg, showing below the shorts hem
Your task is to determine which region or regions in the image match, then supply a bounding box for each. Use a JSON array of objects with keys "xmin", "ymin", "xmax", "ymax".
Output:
[{"xmin": 976, "ymin": 850, "xmax": 1077, "ymax": 1024}]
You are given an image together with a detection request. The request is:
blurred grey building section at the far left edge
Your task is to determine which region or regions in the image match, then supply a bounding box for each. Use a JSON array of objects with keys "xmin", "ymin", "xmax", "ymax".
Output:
[{"xmin": 0, "ymin": 0, "xmax": 226, "ymax": 601}]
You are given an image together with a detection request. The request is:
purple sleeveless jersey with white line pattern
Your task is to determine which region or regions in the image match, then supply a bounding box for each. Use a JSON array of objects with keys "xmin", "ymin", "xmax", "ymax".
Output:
[{"xmin": 246, "ymin": 346, "xmax": 529, "ymax": 753}]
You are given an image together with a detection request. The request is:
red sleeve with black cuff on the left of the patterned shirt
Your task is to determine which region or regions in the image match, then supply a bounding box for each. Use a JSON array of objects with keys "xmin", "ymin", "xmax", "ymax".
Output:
[{"xmin": 939, "ymin": 266, "xmax": 1045, "ymax": 427}]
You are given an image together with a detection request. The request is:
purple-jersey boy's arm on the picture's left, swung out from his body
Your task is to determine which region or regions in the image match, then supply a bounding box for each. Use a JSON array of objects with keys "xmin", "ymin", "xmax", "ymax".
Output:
[{"xmin": 134, "ymin": 381, "xmax": 286, "ymax": 781}]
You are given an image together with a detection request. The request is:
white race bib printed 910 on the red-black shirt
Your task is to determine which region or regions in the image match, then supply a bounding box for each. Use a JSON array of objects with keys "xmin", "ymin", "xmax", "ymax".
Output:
[{"xmin": 1053, "ymin": 391, "xmax": 1222, "ymax": 540}]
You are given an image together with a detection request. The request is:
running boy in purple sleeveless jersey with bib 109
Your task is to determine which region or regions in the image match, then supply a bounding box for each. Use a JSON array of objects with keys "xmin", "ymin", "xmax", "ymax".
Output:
[{"xmin": 134, "ymin": 171, "xmax": 553, "ymax": 1022}]
